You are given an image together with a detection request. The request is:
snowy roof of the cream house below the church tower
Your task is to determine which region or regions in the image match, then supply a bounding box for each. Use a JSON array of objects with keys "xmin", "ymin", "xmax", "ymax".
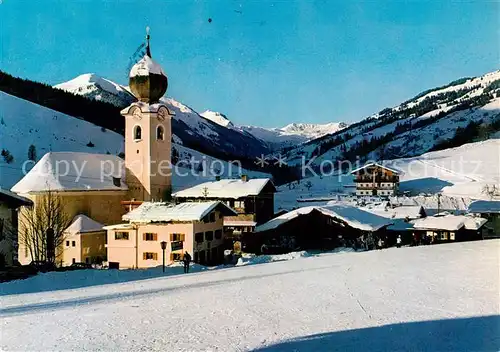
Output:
[{"xmin": 122, "ymin": 201, "xmax": 237, "ymax": 222}]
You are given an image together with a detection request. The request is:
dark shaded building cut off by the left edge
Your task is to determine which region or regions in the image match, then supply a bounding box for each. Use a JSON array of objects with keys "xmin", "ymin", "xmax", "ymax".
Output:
[{"xmin": 0, "ymin": 188, "xmax": 33, "ymax": 269}]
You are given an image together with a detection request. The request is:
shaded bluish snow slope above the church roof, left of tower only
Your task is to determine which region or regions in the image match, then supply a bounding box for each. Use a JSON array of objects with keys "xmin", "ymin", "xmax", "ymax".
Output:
[{"xmin": 0, "ymin": 92, "xmax": 123, "ymax": 188}]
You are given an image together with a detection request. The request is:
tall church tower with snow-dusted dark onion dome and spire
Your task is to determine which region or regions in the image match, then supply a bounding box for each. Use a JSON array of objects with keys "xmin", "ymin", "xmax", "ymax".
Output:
[{"xmin": 121, "ymin": 28, "xmax": 172, "ymax": 201}]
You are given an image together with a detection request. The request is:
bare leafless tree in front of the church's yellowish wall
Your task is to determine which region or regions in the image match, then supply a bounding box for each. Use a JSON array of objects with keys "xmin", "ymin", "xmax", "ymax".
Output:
[{"xmin": 18, "ymin": 190, "xmax": 71, "ymax": 263}]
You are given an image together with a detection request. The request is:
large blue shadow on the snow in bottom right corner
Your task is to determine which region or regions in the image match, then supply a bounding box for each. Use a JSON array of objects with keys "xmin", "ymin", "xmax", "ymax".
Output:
[{"xmin": 254, "ymin": 315, "xmax": 500, "ymax": 352}]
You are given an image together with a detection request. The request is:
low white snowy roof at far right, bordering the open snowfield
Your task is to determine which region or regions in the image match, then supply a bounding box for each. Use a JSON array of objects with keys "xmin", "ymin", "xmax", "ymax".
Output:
[{"xmin": 414, "ymin": 215, "xmax": 488, "ymax": 231}]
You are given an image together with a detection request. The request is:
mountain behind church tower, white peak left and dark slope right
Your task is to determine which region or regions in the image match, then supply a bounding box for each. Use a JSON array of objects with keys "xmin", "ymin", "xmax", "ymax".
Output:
[{"xmin": 55, "ymin": 74, "xmax": 270, "ymax": 159}]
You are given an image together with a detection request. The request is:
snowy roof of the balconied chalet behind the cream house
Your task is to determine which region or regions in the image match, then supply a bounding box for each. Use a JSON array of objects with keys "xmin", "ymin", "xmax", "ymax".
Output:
[{"xmin": 173, "ymin": 178, "xmax": 275, "ymax": 199}]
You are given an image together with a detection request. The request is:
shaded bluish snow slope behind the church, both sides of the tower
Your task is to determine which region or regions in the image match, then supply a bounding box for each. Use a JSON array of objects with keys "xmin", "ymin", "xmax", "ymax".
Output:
[{"xmin": 0, "ymin": 92, "xmax": 271, "ymax": 191}]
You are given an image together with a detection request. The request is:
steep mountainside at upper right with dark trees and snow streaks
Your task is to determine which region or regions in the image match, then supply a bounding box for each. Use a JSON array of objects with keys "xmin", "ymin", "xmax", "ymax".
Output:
[{"xmin": 285, "ymin": 71, "xmax": 500, "ymax": 166}]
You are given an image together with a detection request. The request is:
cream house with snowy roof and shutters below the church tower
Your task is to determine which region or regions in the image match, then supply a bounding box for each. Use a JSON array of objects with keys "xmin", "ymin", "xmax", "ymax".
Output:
[{"xmin": 105, "ymin": 201, "xmax": 236, "ymax": 269}]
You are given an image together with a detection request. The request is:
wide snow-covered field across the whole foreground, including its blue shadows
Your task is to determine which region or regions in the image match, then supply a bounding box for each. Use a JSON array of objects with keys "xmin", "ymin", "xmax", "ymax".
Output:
[{"xmin": 0, "ymin": 240, "xmax": 500, "ymax": 351}]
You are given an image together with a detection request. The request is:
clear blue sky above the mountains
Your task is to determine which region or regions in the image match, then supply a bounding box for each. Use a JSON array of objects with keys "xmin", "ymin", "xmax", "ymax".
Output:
[{"xmin": 0, "ymin": 0, "xmax": 500, "ymax": 127}]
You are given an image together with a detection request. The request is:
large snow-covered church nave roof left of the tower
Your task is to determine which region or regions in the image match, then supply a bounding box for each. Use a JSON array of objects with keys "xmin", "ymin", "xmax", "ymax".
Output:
[{"xmin": 12, "ymin": 152, "xmax": 127, "ymax": 194}]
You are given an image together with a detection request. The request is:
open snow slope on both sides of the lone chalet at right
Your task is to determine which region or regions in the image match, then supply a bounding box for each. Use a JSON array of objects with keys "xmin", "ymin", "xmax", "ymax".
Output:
[{"xmin": 275, "ymin": 139, "xmax": 500, "ymax": 211}]
